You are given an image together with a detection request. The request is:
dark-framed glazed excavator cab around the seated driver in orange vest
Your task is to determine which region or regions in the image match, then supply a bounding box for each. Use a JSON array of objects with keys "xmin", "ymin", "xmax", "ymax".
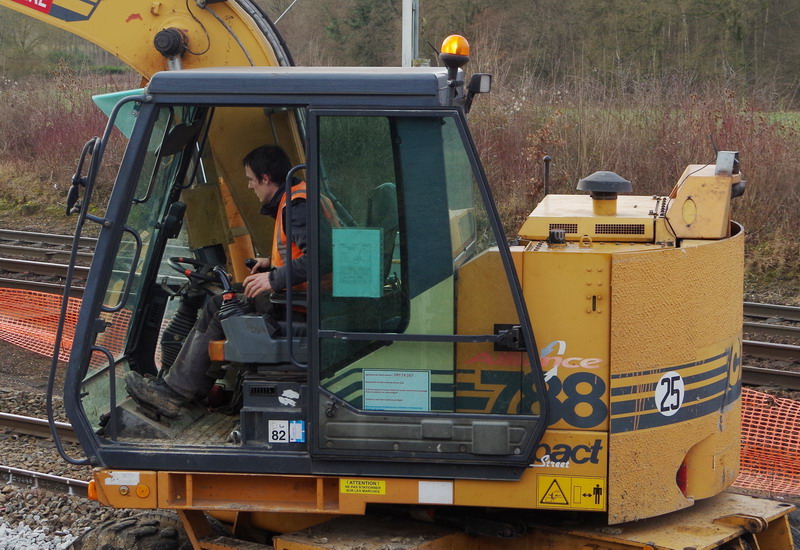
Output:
[{"xmin": 65, "ymin": 64, "xmax": 545, "ymax": 479}]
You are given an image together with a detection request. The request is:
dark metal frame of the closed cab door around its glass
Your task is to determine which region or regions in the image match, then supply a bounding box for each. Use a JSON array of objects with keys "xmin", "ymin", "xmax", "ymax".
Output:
[{"xmin": 306, "ymin": 107, "xmax": 548, "ymax": 479}]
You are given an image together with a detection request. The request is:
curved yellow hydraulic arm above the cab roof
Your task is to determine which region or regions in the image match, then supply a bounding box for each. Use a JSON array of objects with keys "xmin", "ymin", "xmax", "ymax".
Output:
[{"xmin": 0, "ymin": 0, "xmax": 291, "ymax": 78}]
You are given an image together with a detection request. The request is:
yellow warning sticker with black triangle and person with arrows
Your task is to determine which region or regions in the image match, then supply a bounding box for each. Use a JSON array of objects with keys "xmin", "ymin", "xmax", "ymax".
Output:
[{"xmin": 537, "ymin": 475, "xmax": 606, "ymax": 511}]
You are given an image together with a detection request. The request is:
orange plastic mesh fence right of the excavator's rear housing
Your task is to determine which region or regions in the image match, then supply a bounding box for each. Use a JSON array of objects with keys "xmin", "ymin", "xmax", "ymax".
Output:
[{"xmin": 734, "ymin": 388, "xmax": 800, "ymax": 495}]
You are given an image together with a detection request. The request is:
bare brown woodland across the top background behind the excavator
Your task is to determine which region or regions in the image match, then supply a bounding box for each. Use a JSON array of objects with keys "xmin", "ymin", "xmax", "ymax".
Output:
[{"xmin": 0, "ymin": 0, "xmax": 800, "ymax": 102}]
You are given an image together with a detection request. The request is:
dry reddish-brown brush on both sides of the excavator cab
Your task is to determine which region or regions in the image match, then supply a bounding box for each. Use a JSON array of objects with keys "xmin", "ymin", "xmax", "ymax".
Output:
[{"xmin": 0, "ymin": 66, "xmax": 800, "ymax": 294}]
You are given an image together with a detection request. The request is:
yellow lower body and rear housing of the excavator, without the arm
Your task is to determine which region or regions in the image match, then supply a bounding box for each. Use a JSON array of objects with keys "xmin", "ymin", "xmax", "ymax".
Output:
[{"xmin": 84, "ymin": 156, "xmax": 790, "ymax": 550}]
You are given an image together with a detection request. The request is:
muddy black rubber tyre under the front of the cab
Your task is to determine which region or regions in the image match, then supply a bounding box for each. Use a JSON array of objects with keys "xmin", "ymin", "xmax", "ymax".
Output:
[{"xmin": 70, "ymin": 510, "xmax": 192, "ymax": 550}]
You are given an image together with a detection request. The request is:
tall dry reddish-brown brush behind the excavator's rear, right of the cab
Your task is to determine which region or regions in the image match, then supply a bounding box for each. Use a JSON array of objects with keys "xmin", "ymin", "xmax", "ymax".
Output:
[{"xmin": 470, "ymin": 71, "xmax": 800, "ymax": 288}]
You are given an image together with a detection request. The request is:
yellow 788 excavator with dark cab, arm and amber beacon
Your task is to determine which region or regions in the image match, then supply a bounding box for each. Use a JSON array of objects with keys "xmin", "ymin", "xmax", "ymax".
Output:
[{"xmin": 0, "ymin": 0, "xmax": 793, "ymax": 550}]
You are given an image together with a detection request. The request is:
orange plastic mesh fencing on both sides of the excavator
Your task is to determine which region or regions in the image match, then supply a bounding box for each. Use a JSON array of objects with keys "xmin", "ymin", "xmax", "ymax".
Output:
[{"xmin": 0, "ymin": 288, "xmax": 800, "ymax": 495}]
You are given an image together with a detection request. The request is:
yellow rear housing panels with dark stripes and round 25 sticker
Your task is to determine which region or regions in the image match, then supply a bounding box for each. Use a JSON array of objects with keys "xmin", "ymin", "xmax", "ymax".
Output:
[{"xmin": 523, "ymin": 230, "xmax": 743, "ymax": 523}]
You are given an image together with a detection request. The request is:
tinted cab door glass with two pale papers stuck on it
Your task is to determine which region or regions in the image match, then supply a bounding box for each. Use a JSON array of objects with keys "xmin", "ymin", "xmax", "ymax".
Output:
[{"xmin": 317, "ymin": 114, "xmax": 537, "ymax": 414}]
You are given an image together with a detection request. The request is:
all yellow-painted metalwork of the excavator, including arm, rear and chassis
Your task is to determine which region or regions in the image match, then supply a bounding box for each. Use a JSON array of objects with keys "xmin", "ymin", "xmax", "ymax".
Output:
[{"xmin": 0, "ymin": 0, "xmax": 791, "ymax": 550}]
